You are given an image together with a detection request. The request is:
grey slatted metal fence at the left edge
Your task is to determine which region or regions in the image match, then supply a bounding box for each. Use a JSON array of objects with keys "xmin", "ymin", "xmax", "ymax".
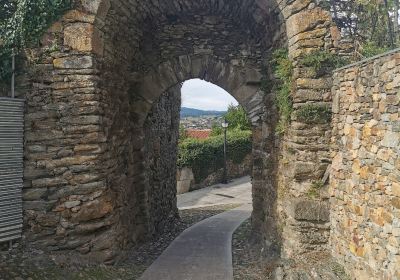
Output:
[{"xmin": 0, "ymin": 97, "xmax": 24, "ymax": 242}]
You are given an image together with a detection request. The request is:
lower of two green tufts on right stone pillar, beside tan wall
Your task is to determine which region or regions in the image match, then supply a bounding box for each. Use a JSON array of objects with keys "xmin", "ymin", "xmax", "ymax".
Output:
[{"xmin": 296, "ymin": 104, "xmax": 332, "ymax": 124}]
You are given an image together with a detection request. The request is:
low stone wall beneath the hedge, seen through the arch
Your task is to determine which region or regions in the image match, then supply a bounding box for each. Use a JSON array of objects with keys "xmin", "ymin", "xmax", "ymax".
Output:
[{"xmin": 177, "ymin": 155, "xmax": 252, "ymax": 194}]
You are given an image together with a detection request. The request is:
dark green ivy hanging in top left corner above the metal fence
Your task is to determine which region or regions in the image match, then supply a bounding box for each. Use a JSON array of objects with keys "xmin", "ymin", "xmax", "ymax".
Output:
[{"xmin": 0, "ymin": 0, "xmax": 72, "ymax": 81}]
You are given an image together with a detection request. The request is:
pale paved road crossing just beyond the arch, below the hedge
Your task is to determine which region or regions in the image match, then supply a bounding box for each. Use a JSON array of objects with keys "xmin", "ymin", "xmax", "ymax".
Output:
[{"xmin": 177, "ymin": 177, "xmax": 252, "ymax": 209}]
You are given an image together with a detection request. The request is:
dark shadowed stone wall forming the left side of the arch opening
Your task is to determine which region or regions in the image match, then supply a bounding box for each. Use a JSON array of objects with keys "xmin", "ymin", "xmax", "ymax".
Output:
[{"xmin": 144, "ymin": 87, "xmax": 181, "ymax": 233}]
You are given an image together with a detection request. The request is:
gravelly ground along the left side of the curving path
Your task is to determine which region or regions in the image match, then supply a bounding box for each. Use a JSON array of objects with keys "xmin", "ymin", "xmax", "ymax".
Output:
[{"xmin": 0, "ymin": 204, "xmax": 244, "ymax": 280}]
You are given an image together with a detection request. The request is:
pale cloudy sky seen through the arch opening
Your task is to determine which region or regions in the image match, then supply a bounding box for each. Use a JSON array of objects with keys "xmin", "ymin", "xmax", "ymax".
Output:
[{"xmin": 181, "ymin": 79, "xmax": 238, "ymax": 111}]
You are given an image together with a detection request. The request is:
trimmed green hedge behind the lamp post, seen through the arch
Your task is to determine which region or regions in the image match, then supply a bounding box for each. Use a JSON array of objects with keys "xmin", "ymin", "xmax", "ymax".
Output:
[{"xmin": 177, "ymin": 130, "xmax": 252, "ymax": 183}]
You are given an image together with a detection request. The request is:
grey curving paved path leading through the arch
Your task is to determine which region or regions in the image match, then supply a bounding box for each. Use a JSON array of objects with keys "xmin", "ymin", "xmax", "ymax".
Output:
[{"xmin": 140, "ymin": 204, "xmax": 251, "ymax": 280}]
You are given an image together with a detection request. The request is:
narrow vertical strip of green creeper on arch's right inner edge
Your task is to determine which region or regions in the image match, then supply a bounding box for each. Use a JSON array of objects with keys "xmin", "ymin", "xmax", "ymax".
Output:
[{"xmin": 270, "ymin": 49, "xmax": 293, "ymax": 134}]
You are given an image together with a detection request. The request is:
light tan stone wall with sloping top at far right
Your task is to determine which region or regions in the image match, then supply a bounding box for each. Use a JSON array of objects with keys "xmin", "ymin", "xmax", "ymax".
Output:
[{"xmin": 331, "ymin": 50, "xmax": 400, "ymax": 279}]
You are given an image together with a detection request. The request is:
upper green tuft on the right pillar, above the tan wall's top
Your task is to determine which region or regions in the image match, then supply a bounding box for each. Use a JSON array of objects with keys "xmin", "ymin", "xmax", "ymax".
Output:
[{"xmin": 299, "ymin": 50, "xmax": 349, "ymax": 76}]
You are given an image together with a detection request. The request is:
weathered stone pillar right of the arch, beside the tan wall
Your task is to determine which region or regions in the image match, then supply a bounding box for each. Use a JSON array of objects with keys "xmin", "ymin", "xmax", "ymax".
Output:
[{"xmin": 278, "ymin": 0, "xmax": 335, "ymax": 257}]
